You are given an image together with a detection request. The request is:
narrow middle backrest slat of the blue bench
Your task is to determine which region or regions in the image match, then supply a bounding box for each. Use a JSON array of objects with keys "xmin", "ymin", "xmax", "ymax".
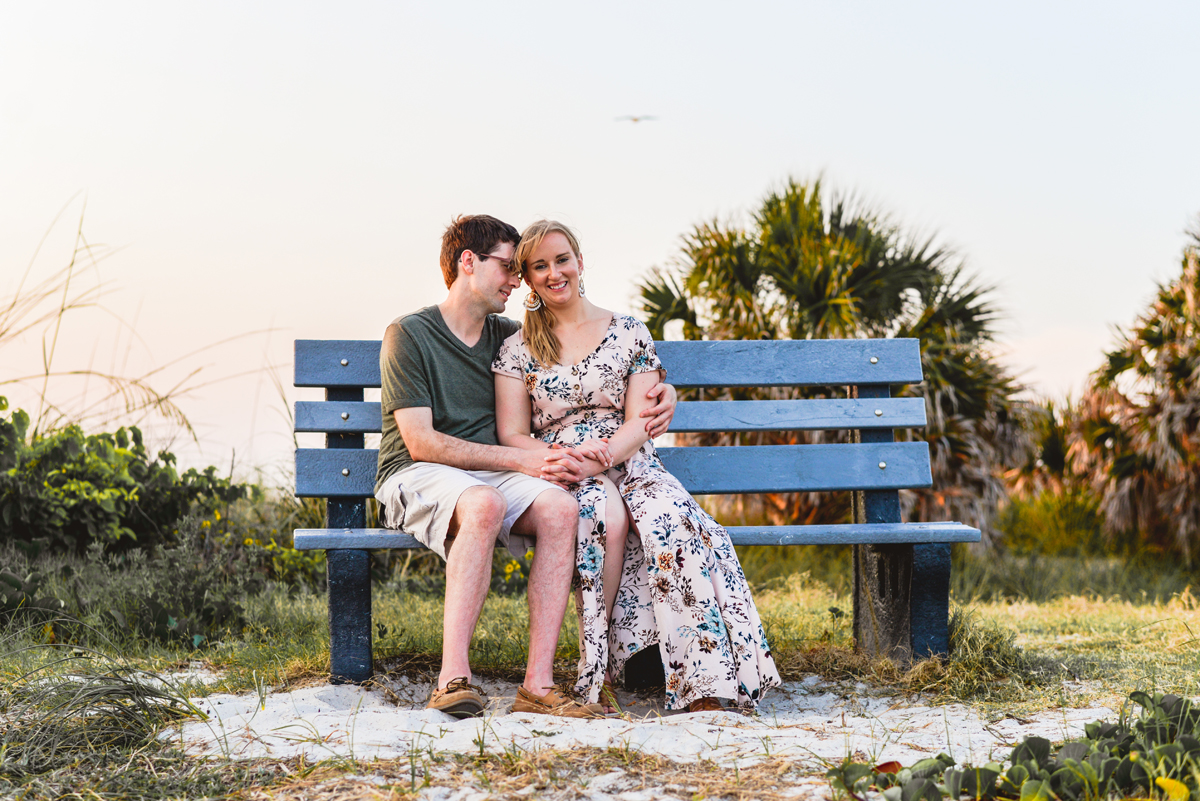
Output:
[{"xmin": 295, "ymin": 398, "xmax": 925, "ymax": 434}]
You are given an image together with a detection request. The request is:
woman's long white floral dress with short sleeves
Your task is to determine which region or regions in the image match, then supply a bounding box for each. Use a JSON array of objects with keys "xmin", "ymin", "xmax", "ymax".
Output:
[{"xmin": 492, "ymin": 314, "xmax": 780, "ymax": 709}]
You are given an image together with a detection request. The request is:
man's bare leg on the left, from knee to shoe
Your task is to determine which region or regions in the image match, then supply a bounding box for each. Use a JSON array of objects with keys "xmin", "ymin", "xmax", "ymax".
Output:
[{"xmin": 438, "ymin": 486, "xmax": 506, "ymax": 689}]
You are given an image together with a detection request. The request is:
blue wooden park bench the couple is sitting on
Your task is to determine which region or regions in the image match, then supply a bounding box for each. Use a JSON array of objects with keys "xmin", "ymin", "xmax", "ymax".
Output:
[{"xmin": 294, "ymin": 339, "xmax": 979, "ymax": 682}]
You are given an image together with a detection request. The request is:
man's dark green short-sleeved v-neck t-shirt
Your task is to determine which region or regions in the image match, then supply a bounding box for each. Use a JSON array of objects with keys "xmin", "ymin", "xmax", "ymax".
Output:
[{"xmin": 376, "ymin": 306, "xmax": 521, "ymax": 492}]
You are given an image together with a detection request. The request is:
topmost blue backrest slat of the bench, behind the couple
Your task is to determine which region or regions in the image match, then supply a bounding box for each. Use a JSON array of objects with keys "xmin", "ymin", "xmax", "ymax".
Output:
[{"xmin": 295, "ymin": 339, "xmax": 922, "ymax": 387}]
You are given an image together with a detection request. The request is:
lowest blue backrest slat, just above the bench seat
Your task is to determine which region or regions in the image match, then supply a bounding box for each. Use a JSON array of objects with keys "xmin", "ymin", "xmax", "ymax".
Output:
[{"xmin": 296, "ymin": 442, "xmax": 934, "ymax": 498}]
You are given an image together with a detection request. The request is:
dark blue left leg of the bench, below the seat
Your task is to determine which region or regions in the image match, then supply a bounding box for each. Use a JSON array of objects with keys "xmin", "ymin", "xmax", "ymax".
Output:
[{"xmin": 325, "ymin": 550, "xmax": 373, "ymax": 685}]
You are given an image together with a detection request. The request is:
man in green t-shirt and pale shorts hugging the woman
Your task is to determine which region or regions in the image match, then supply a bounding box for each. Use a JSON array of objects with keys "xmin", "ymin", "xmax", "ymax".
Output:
[{"xmin": 376, "ymin": 215, "xmax": 676, "ymax": 717}]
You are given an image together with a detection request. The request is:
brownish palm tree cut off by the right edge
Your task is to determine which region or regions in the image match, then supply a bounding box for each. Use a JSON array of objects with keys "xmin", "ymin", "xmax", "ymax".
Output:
[{"xmin": 1069, "ymin": 217, "xmax": 1200, "ymax": 564}]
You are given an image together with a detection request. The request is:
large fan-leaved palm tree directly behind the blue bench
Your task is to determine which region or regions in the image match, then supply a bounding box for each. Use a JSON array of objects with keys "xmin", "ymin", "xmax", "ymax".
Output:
[{"xmin": 640, "ymin": 180, "xmax": 1031, "ymax": 531}]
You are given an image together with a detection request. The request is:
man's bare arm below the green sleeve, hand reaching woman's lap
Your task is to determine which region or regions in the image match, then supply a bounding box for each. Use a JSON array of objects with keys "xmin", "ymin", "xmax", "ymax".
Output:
[{"xmin": 392, "ymin": 406, "xmax": 582, "ymax": 484}]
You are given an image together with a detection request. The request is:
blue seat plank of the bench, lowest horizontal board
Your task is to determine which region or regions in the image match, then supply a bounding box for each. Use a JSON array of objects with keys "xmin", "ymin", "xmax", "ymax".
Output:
[{"xmin": 295, "ymin": 523, "xmax": 979, "ymax": 550}]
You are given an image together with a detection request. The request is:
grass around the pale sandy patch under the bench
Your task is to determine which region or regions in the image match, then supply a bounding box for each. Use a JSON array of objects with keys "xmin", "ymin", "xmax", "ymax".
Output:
[{"xmin": 7, "ymin": 546, "xmax": 1200, "ymax": 799}]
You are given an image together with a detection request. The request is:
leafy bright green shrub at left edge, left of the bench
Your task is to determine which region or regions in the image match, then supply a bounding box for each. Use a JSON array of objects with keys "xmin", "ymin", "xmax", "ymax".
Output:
[{"xmin": 0, "ymin": 398, "xmax": 254, "ymax": 552}]
